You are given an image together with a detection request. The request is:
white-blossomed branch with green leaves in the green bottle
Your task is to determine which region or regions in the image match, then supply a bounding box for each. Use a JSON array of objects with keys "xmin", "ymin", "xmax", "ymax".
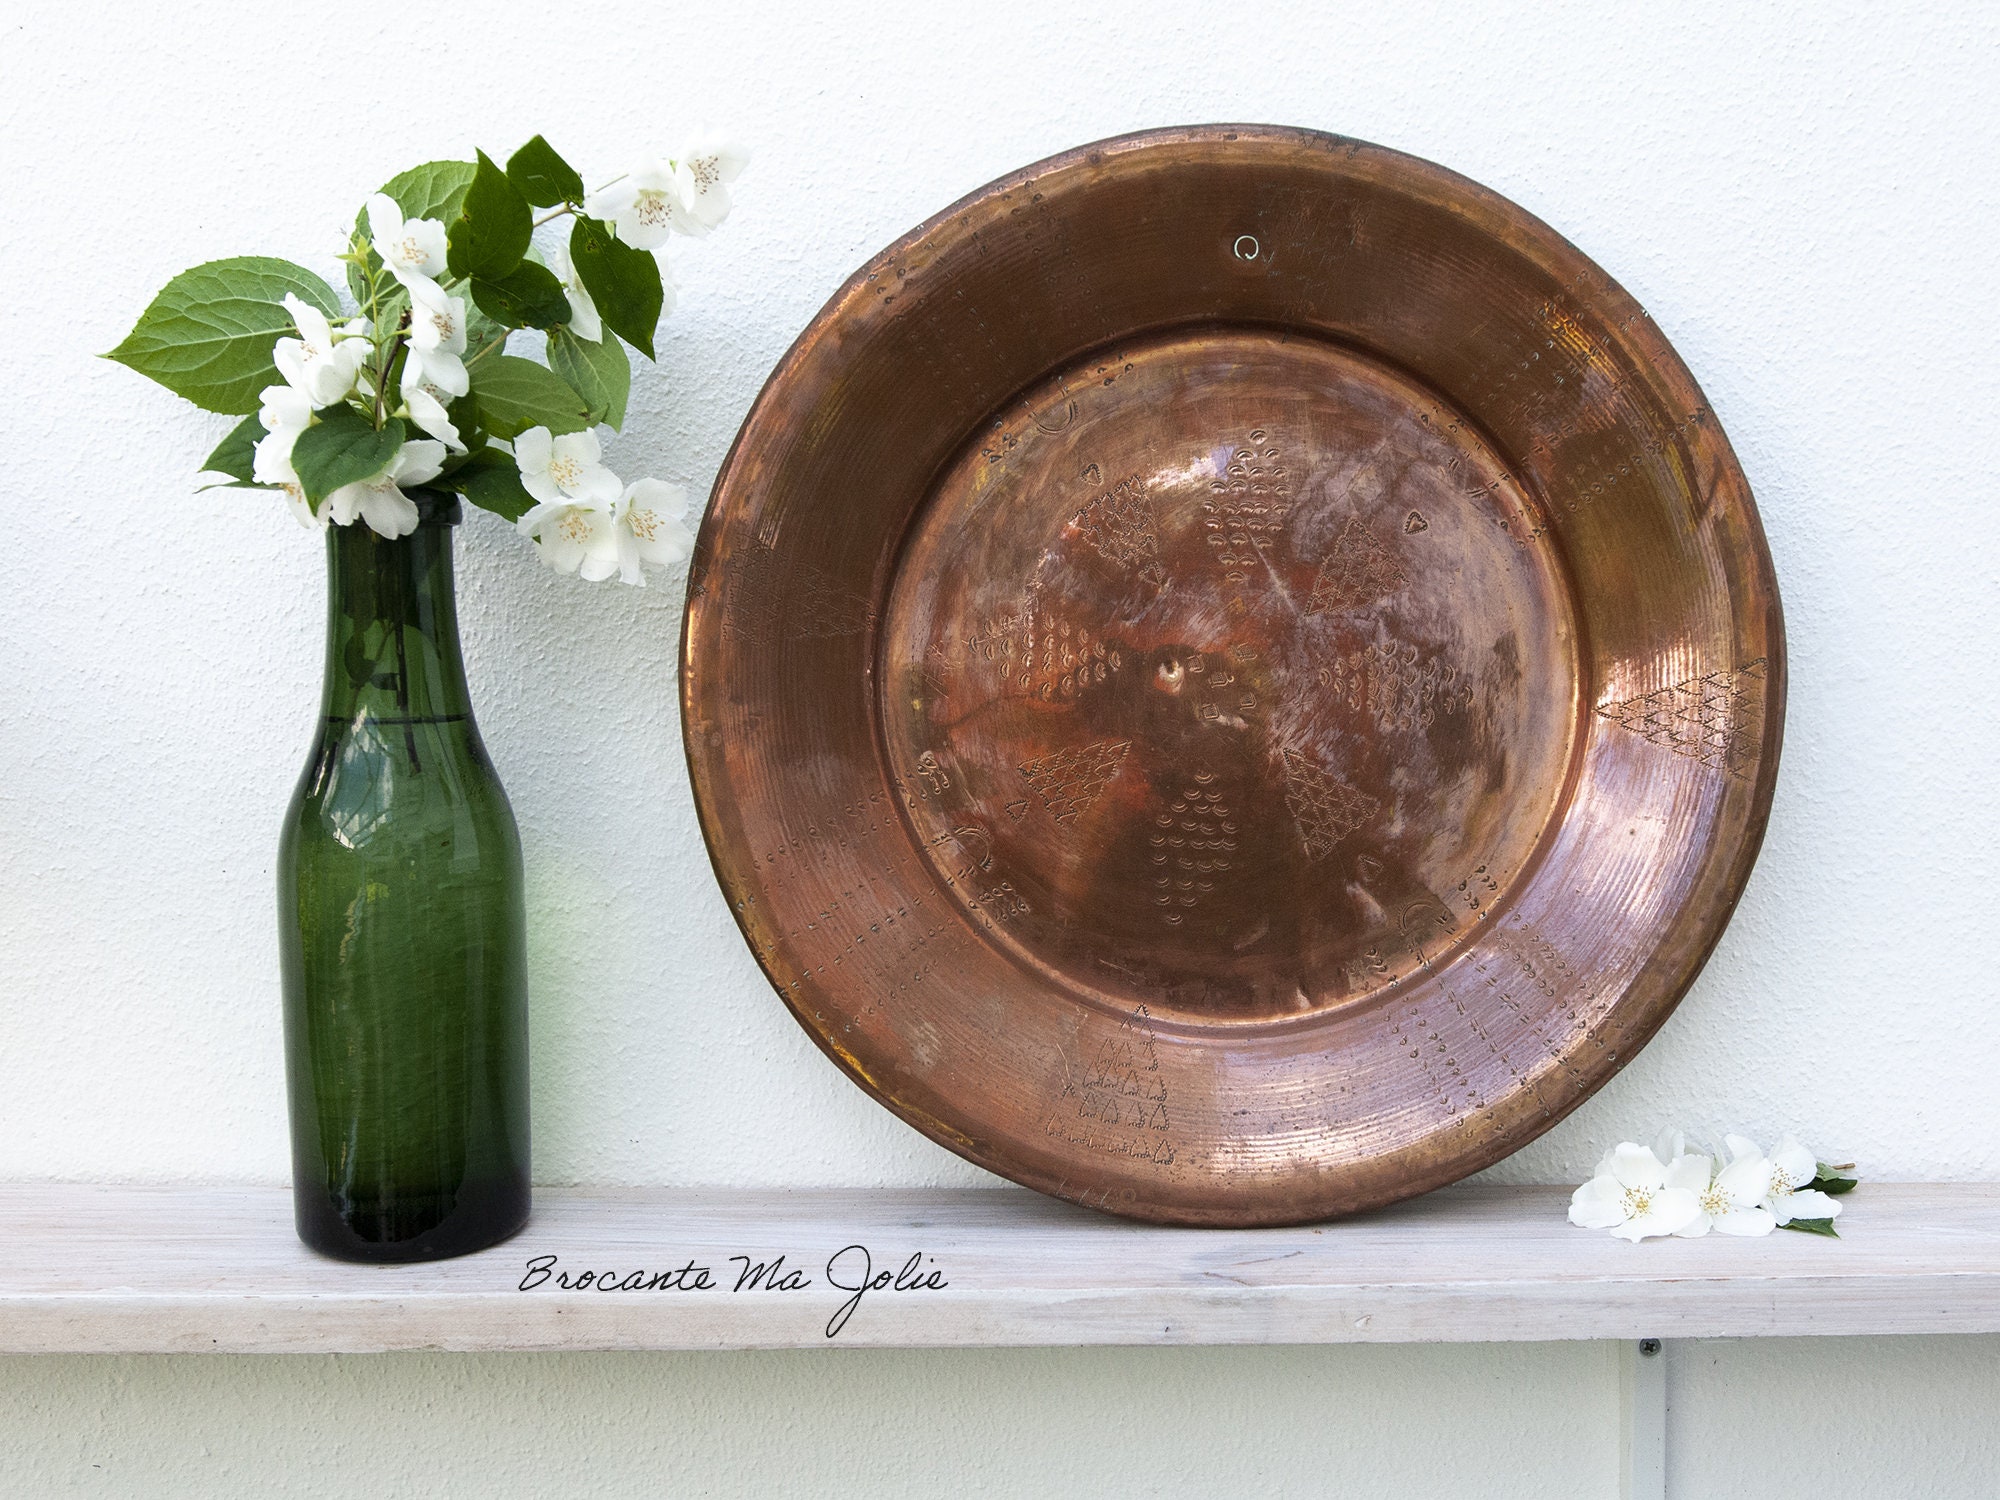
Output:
[{"xmin": 110, "ymin": 136, "xmax": 746, "ymax": 584}]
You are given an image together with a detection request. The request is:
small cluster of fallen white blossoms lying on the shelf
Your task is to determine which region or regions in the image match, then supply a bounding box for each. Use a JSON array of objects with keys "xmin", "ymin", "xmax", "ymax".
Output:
[{"xmin": 1570, "ymin": 1130, "xmax": 1858, "ymax": 1242}]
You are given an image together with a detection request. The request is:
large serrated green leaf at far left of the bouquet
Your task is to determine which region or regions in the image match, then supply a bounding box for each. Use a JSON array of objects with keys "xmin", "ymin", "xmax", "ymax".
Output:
[{"xmin": 104, "ymin": 256, "xmax": 340, "ymax": 416}]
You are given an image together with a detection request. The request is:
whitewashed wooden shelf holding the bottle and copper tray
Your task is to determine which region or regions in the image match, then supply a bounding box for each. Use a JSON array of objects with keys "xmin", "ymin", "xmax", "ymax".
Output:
[{"xmin": 0, "ymin": 1182, "xmax": 2000, "ymax": 1354}]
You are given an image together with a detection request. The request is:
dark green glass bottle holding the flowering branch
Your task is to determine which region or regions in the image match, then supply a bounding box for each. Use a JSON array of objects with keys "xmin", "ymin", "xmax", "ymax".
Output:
[{"xmin": 278, "ymin": 490, "xmax": 528, "ymax": 1260}]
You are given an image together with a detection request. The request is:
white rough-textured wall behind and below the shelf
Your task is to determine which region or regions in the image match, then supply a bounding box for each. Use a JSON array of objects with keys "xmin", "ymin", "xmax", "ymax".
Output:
[{"xmin": 0, "ymin": 0, "xmax": 2000, "ymax": 1496}]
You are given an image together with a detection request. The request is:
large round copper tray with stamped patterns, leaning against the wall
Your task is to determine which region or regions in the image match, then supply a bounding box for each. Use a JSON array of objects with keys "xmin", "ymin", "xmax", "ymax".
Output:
[{"xmin": 682, "ymin": 126, "xmax": 1784, "ymax": 1224}]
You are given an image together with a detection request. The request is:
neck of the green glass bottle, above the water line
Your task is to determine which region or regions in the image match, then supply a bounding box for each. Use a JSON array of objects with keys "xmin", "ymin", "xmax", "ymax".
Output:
[{"xmin": 320, "ymin": 492, "xmax": 472, "ymax": 722}]
